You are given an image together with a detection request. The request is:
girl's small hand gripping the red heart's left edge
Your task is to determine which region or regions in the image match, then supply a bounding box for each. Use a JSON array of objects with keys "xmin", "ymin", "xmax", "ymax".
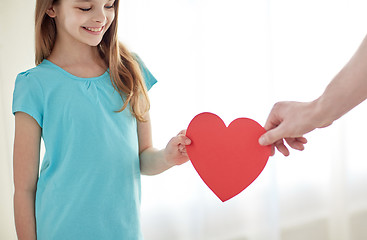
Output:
[{"xmin": 164, "ymin": 130, "xmax": 191, "ymax": 166}]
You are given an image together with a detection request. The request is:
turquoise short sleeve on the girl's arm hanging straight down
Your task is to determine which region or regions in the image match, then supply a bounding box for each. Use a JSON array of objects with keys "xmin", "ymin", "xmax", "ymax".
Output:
[{"xmin": 12, "ymin": 71, "xmax": 44, "ymax": 127}]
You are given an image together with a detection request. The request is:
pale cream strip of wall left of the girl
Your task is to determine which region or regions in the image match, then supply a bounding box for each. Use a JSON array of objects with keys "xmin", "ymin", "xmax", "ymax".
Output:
[{"xmin": 0, "ymin": 0, "xmax": 35, "ymax": 240}]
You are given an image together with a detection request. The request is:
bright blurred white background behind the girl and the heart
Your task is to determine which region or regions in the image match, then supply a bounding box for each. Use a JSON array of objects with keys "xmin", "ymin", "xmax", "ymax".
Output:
[{"xmin": 0, "ymin": 0, "xmax": 367, "ymax": 240}]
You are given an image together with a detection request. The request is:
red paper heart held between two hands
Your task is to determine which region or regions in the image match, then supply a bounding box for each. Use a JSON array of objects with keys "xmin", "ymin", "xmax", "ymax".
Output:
[{"xmin": 186, "ymin": 112, "xmax": 271, "ymax": 202}]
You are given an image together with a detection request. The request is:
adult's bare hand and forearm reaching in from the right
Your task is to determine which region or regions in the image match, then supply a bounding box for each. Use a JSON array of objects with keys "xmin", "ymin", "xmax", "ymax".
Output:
[{"xmin": 259, "ymin": 36, "xmax": 367, "ymax": 156}]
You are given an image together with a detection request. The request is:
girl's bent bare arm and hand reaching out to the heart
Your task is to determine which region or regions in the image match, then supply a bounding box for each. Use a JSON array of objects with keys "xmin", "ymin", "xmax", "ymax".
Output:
[{"xmin": 138, "ymin": 113, "xmax": 191, "ymax": 175}]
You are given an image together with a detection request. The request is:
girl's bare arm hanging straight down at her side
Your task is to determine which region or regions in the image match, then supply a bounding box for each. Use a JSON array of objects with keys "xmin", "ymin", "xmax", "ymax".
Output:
[{"xmin": 13, "ymin": 112, "xmax": 41, "ymax": 240}]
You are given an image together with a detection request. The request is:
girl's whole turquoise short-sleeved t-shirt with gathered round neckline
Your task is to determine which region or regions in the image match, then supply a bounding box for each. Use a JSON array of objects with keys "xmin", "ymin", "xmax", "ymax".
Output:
[{"xmin": 12, "ymin": 57, "xmax": 156, "ymax": 240}]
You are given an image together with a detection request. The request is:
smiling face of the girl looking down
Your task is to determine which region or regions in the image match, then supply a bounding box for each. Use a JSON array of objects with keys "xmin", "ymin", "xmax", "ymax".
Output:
[{"xmin": 47, "ymin": 0, "xmax": 115, "ymax": 46}]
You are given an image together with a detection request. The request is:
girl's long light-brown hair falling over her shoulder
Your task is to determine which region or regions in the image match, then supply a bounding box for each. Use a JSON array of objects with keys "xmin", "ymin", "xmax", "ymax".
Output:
[{"xmin": 35, "ymin": 0, "xmax": 150, "ymax": 121}]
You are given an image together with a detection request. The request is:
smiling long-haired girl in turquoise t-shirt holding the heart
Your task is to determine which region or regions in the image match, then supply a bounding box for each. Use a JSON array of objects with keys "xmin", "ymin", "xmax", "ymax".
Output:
[{"xmin": 12, "ymin": 0, "xmax": 190, "ymax": 240}]
